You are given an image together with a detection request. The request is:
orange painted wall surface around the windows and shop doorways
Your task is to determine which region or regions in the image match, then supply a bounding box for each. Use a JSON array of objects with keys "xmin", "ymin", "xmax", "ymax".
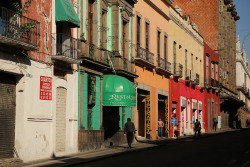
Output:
[{"xmin": 133, "ymin": 0, "xmax": 169, "ymax": 139}]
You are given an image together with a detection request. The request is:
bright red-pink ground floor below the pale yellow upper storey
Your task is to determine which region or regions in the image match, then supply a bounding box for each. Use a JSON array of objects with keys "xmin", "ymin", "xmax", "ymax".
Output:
[{"xmin": 170, "ymin": 78, "xmax": 206, "ymax": 137}]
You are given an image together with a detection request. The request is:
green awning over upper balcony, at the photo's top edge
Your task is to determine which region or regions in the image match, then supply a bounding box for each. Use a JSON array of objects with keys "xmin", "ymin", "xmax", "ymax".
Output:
[{"xmin": 56, "ymin": 0, "xmax": 80, "ymax": 28}]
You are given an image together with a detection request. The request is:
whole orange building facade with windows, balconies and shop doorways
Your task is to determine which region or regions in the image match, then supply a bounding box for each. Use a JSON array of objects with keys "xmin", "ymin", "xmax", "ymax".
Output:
[{"xmin": 133, "ymin": 0, "xmax": 172, "ymax": 139}]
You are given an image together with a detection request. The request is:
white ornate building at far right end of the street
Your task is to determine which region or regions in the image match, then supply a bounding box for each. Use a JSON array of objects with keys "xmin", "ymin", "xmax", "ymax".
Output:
[{"xmin": 236, "ymin": 36, "xmax": 250, "ymax": 127}]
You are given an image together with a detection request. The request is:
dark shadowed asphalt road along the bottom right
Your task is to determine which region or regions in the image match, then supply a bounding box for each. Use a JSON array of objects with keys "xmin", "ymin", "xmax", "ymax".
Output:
[{"xmin": 76, "ymin": 129, "xmax": 250, "ymax": 167}]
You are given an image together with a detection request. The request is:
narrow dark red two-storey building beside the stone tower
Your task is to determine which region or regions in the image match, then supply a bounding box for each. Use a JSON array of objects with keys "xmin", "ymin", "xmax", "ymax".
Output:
[{"xmin": 204, "ymin": 42, "xmax": 221, "ymax": 132}]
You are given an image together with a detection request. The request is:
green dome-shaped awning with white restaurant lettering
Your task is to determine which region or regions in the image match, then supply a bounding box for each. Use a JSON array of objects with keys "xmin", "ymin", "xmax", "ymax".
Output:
[{"xmin": 102, "ymin": 75, "xmax": 136, "ymax": 107}]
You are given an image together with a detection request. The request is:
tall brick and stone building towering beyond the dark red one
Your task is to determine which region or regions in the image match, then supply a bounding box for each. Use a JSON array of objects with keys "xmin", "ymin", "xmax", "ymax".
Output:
[{"xmin": 173, "ymin": 0, "xmax": 242, "ymax": 128}]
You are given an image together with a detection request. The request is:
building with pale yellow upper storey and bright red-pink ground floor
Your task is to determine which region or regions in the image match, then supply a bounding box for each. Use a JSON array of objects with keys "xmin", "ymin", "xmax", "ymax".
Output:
[{"xmin": 169, "ymin": 6, "xmax": 205, "ymax": 137}]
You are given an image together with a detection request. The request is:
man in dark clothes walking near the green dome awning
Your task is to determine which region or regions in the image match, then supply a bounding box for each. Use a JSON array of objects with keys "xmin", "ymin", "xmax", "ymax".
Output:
[{"xmin": 124, "ymin": 118, "xmax": 135, "ymax": 148}]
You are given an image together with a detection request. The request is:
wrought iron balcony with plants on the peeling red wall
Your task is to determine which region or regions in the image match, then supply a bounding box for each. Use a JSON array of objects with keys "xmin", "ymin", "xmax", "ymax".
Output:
[{"xmin": 0, "ymin": 7, "xmax": 40, "ymax": 50}]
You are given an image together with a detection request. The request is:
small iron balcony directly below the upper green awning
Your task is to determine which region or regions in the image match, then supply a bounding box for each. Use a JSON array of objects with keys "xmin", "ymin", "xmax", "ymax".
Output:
[{"xmin": 52, "ymin": 33, "xmax": 80, "ymax": 64}]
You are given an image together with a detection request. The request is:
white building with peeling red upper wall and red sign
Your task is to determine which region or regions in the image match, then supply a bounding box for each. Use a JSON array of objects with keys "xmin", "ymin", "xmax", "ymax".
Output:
[{"xmin": 0, "ymin": 0, "xmax": 80, "ymax": 166}]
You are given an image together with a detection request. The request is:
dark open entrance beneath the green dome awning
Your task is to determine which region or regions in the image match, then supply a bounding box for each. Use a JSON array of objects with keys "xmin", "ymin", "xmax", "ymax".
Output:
[{"xmin": 103, "ymin": 106, "xmax": 120, "ymax": 140}]
